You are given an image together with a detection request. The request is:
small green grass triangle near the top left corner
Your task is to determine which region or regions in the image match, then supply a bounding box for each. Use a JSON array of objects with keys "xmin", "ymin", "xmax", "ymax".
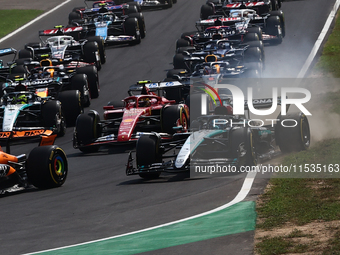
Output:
[{"xmin": 0, "ymin": 10, "xmax": 43, "ymax": 38}]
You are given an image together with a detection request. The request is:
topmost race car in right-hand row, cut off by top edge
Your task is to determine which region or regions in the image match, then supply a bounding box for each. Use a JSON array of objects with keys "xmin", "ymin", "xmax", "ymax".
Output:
[{"xmin": 201, "ymin": 0, "xmax": 282, "ymax": 19}]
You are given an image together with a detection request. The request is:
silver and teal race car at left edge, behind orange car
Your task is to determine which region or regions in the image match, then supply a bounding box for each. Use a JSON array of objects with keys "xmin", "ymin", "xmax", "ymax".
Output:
[{"xmin": 0, "ymin": 91, "xmax": 67, "ymax": 141}]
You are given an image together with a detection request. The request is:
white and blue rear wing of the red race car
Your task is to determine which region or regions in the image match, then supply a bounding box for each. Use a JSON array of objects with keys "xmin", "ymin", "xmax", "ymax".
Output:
[{"xmin": 128, "ymin": 80, "xmax": 186, "ymax": 96}]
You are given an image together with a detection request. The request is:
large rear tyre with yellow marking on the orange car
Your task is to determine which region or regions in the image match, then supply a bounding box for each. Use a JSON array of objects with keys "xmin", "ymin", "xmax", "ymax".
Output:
[{"xmin": 26, "ymin": 145, "xmax": 68, "ymax": 189}]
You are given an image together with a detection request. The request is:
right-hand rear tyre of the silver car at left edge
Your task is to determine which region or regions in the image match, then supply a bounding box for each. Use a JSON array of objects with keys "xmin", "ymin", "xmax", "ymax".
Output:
[{"xmin": 58, "ymin": 90, "xmax": 83, "ymax": 127}]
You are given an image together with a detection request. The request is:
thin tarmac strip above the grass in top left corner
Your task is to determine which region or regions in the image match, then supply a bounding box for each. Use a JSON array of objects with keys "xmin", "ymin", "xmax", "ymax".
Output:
[{"xmin": 0, "ymin": 0, "xmax": 65, "ymax": 11}]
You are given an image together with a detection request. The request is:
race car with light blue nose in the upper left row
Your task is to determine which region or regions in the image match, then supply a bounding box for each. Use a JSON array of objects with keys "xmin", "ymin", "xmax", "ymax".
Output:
[{"xmin": 69, "ymin": 1, "xmax": 146, "ymax": 40}]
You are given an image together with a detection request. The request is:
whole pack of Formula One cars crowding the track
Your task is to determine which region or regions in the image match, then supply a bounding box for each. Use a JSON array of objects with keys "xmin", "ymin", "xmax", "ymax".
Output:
[{"xmin": 0, "ymin": 0, "xmax": 310, "ymax": 192}]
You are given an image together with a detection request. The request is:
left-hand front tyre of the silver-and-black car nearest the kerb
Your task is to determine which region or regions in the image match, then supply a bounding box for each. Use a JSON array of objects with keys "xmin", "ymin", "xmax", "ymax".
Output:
[{"xmin": 136, "ymin": 134, "xmax": 162, "ymax": 179}]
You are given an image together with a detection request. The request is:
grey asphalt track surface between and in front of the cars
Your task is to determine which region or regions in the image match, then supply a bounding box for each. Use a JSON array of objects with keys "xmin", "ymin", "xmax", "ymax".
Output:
[{"xmin": 0, "ymin": 0, "xmax": 335, "ymax": 255}]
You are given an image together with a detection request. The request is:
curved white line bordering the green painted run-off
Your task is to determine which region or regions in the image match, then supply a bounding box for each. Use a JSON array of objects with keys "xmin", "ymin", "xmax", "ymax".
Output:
[{"xmin": 24, "ymin": 171, "xmax": 256, "ymax": 255}]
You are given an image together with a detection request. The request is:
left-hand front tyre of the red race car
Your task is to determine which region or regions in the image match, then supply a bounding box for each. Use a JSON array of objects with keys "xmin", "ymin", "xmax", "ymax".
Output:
[{"xmin": 74, "ymin": 111, "xmax": 100, "ymax": 153}]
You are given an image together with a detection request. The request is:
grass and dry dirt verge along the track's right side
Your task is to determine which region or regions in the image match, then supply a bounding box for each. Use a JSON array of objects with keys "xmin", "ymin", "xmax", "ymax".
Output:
[{"xmin": 255, "ymin": 10, "xmax": 340, "ymax": 255}]
